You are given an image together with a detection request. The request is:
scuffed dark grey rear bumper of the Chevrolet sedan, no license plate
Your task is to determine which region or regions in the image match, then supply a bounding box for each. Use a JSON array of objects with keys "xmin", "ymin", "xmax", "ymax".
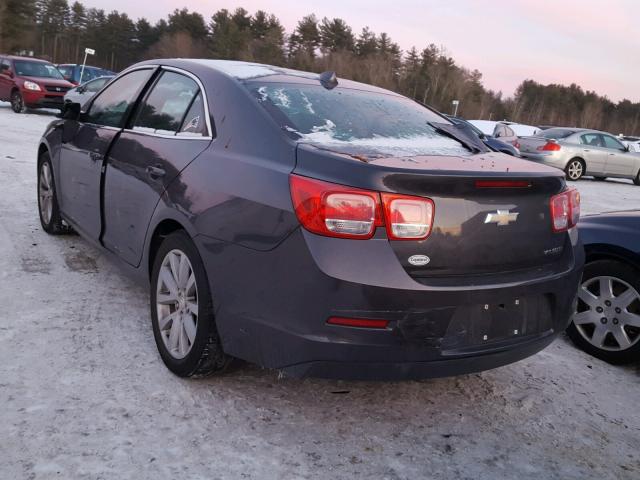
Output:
[{"xmin": 196, "ymin": 229, "xmax": 584, "ymax": 380}]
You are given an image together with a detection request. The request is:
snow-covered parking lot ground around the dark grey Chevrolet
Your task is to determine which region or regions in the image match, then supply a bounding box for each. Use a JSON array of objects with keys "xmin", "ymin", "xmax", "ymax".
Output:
[{"xmin": 0, "ymin": 103, "xmax": 640, "ymax": 480}]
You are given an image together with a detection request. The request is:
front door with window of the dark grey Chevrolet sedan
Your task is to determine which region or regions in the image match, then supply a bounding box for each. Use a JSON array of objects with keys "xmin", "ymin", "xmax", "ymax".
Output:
[{"xmin": 57, "ymin": 68, "xmax": 153, "ymax": 240}]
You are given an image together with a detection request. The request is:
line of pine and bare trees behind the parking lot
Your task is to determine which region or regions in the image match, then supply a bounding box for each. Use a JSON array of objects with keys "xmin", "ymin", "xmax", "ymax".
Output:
[{"xmin": 0, "ymin": 0, "xmax": 640, "ymax": 134}]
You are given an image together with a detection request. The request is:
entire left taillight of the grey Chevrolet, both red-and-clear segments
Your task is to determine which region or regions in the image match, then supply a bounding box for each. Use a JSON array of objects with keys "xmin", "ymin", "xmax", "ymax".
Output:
[{"xmin": 289, "ymin": 175, "xmax": 434, "ymax": 240}]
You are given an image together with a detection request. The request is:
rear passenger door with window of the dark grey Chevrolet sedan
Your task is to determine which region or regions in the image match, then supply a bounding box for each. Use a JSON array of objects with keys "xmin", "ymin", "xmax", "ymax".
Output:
[{"xmin": 103, "ymin": 68, "xmax": 212, "ymax": 266}]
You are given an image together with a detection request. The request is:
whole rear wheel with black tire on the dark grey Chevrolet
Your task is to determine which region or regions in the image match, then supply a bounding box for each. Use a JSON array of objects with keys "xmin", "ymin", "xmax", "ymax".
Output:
[{"xmin": 151, "ymin": 230, "xmax": 231, "ymax": 377}]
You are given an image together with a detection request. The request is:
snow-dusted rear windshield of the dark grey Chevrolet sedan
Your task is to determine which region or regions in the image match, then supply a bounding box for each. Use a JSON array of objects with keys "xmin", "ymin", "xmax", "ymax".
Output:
[{"xmin": 245, "ymin": 81, "xmax": 471, "ymax": 157}]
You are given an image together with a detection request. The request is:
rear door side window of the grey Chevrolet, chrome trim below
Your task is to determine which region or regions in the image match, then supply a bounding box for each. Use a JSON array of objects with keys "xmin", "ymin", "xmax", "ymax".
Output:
[{"xmin": 133, "ymin": 71, "xmax": 207, "ymax": 136}]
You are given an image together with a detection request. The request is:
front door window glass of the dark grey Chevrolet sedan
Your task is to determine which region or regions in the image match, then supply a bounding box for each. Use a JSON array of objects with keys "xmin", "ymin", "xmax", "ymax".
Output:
[{"xmin": 84, "ymin": 70, "xmax": 152, "ymax": 127}]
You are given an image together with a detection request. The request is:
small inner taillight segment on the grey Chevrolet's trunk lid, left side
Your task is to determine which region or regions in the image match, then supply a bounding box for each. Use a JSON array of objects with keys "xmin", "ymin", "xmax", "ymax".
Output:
[{"xmin": 382, "ymin": 193, "xmax": 434, "ymax": 240}]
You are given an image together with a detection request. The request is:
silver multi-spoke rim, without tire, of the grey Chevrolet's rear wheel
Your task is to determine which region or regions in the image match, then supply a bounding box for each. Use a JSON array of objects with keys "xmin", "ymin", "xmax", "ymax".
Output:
[{"xmin": 156, "ymin": 249, "xmax": 198, "ymax": 360}]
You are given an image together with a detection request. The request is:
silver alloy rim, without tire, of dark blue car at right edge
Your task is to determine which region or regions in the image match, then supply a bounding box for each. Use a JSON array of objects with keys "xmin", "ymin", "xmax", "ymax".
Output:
[{"xmin": 572, "ymin": 276, "xmax": 640, "ymax": 351}]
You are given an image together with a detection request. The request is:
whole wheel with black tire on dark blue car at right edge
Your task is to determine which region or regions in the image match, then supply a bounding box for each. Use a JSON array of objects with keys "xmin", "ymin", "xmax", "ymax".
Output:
[{"xmin": 567, "ymin": 260, "xmax": 640, "ymax": 365}]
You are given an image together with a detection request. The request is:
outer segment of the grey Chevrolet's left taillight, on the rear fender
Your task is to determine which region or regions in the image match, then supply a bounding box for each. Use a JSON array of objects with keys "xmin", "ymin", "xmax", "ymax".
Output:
[{"xmin": 290, "ymin": 175, "xmax": 383, "ymax": 239}]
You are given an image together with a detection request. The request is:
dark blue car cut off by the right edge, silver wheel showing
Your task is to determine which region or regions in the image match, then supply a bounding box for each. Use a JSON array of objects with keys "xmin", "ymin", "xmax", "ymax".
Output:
[{"xmin": 567, "ymin": 210, "xmax": 640, "ymax": 364}]
